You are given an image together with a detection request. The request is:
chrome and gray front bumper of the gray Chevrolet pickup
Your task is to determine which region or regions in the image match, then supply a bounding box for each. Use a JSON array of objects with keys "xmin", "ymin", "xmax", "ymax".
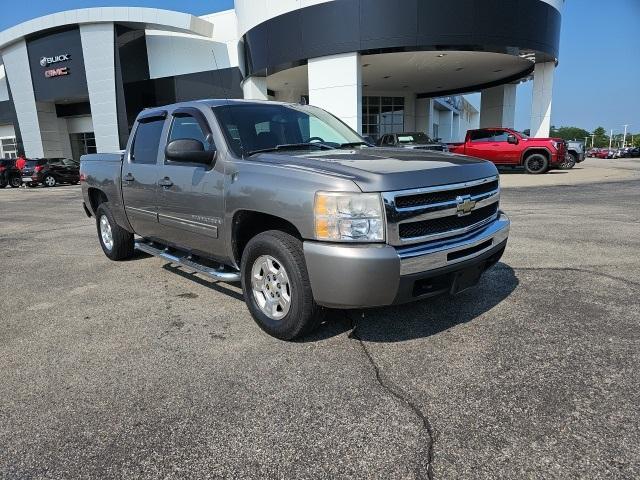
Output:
[{"xmin": 304, "ymin": 213, "xmax": 510, "ymax": 308}]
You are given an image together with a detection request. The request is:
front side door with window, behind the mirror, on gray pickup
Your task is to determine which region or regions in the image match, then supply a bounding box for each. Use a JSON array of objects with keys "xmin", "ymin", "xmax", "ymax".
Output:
[{"xmin": 158, "ymin": 107, "xmax": 224, "ymax": 257}]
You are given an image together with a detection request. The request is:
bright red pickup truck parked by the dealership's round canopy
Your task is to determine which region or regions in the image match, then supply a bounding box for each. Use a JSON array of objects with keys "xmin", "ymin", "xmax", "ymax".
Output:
[{"xmin": 449, "ymin": 128, "xmax": 567, "ymax": 173}]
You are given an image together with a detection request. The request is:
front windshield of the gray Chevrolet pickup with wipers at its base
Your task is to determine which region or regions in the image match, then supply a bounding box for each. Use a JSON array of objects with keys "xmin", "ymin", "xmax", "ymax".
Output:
[{"xmin": 213, "ymin": 104, "xmax": 365, "ymax": 157}]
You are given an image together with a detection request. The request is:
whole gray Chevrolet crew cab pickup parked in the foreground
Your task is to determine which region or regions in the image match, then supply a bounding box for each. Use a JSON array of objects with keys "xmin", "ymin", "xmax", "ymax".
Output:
[{"xmin": 80, "ymin": 100, "xmax": 509, "ymax": 340}]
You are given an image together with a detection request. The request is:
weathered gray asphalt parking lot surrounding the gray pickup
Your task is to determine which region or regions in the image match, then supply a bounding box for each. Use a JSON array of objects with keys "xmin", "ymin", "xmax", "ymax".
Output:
[{"xmin": 0, "ymin": 160, "xmax": 640, "ymax": 479}]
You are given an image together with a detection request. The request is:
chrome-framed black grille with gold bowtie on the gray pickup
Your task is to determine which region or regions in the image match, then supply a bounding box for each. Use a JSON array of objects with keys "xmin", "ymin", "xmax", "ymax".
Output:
[{"xmin": 383, "ymin": 176, "xmax": 500, "ymax": 246}]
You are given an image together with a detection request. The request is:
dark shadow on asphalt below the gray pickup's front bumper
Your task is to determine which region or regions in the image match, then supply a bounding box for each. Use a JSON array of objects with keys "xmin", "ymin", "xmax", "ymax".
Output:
[{"xmin": 303, "ymin": 263, "xmax": 519, "ymax": 343}]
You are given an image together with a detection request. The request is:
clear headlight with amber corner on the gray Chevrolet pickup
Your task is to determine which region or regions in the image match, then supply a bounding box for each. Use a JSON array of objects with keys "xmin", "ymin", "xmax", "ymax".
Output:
[{"xmin": 313, "ymin": 192, "xmax": 384, "ymax": 242}]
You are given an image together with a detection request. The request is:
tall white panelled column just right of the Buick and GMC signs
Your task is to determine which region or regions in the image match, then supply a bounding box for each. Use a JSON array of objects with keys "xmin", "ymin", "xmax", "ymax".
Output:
[{"xmin": 80, "ymin": 23, "xmax": 120, "ymax": 152}]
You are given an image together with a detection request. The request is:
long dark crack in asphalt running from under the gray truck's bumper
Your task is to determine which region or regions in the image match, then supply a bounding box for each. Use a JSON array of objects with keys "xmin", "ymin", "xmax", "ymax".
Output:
[{"xmin": 344, "ymin": 311, "xmax": 437, "ymax": 480}]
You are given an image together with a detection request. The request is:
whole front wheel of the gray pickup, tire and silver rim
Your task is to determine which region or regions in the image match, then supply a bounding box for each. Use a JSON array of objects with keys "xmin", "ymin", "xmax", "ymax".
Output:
[{"xmin": 241, "ymin": 230, "xmax": 322, "ymax": 340}]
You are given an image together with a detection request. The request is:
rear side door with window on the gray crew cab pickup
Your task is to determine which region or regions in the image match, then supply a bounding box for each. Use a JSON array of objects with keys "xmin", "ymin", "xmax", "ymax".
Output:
[{"xmin": 121, "ymin": 112, "xmax": 166, "ymax": 238}]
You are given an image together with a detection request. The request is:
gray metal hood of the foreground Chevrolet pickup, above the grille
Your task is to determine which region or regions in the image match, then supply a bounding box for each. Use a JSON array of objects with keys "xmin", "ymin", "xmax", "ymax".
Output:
[{"xmin": 253, "ymin": 148, "xmax": 498, "ymax": 192}]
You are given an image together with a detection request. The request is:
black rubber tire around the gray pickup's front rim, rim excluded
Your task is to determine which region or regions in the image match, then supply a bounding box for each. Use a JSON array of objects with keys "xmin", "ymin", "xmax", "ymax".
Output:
[{"xmin": 241, "ymin": 230, "xmax": 323, "ymax": 340}]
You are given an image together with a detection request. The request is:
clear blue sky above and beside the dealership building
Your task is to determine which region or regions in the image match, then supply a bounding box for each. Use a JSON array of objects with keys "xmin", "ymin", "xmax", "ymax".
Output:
[{"xmin": 0, "ymin": 0, "xmax": 640, "ymax": 132}]
